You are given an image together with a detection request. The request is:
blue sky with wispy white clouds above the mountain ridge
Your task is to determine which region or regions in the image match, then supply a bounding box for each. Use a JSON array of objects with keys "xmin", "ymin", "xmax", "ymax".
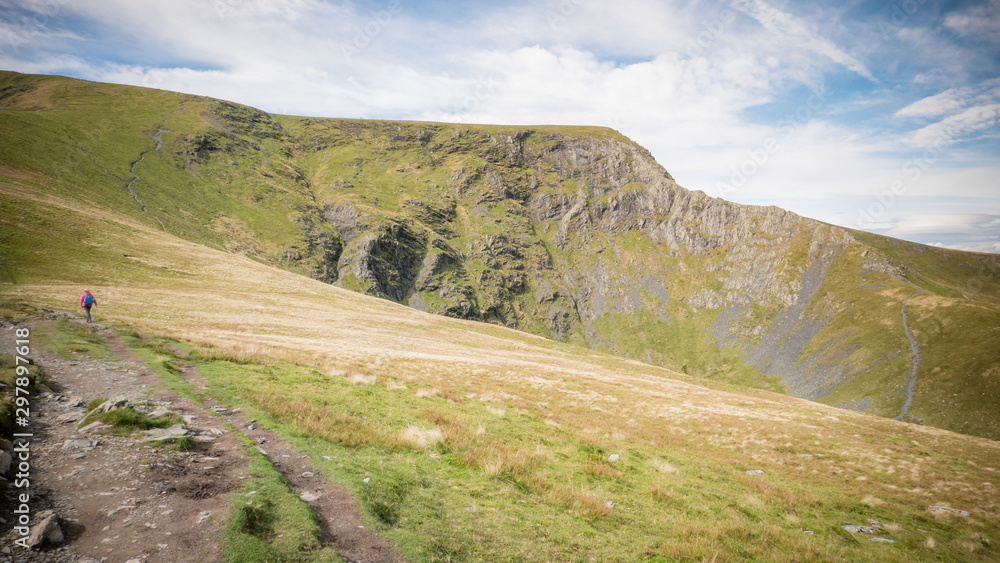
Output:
[{"xmin": 0, "ymin": 0, "xmax": 1000, "ymax": 253}]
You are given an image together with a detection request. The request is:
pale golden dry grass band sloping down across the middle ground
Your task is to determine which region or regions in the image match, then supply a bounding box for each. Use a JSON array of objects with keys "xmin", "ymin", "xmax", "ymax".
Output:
[{"xmin": 3, "ymin": 191, "xmax": 1000, "ymax": 560}]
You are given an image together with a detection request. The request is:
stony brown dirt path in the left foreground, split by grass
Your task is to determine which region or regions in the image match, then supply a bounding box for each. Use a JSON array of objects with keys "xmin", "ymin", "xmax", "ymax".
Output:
[{"xmin": 0, "ymin": 322, "xmax": 402, "ymax": 563}]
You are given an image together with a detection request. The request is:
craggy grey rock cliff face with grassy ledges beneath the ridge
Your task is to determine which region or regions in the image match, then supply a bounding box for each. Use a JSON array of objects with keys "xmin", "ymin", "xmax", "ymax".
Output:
[{"xmin": 284, "ymin": 120, "xmax": 854, "ymax": 382}]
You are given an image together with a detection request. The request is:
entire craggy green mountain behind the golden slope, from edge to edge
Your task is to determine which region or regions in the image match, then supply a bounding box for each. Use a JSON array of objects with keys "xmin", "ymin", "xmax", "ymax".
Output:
[{"xmin": 0, "ymin": 73, "xmax": 1000, "ymax": 439}]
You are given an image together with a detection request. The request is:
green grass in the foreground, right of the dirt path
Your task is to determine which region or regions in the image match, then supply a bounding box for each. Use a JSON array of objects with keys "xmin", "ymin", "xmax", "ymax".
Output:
[{"xmin": 164, "ymin": 354, "xmax": 982, "ymax": 561}]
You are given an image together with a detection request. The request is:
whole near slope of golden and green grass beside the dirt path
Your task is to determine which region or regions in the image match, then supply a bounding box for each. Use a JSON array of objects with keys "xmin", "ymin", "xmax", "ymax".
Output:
[{"xmin": 0, "ymin": 148, "xmax": 1000, "ymax": 561}]
